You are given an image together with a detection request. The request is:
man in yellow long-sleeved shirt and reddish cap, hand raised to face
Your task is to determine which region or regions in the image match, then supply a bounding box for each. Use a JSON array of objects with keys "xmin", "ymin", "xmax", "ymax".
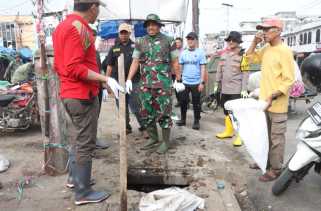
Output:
[{"xmin": 246, "ymin": 18, "xmax": 294, "ymax": 182}]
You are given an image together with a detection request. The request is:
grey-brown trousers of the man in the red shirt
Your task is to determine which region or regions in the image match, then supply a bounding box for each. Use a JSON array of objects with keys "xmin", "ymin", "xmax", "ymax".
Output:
[{"xmin": 63, "ymin": 97, "xmax": 99, "ymax": 164}]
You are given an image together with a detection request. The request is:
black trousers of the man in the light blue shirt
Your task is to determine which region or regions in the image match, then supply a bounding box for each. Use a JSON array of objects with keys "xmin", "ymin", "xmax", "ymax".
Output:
[{"xmin": 179, "ymin": 84, "xmax": 201, "ymax": 120}]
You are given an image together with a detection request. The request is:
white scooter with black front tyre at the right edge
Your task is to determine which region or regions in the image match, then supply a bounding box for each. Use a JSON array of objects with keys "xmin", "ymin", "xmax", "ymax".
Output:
[{"xmin": 272, "ymin": 102, "xmax": 321, "ymax": 196}]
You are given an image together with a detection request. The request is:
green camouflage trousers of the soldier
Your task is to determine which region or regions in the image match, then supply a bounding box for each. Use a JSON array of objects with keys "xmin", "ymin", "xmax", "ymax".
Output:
[{"xmin": 139, "ymin": 87, "xmax": 173, "ymax": 128}]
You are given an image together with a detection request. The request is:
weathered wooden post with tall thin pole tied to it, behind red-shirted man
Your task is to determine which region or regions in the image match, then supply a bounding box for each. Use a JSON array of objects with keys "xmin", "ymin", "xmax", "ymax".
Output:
[{"xmin": 35, "ymin": 0, "xmax": 68, "ymax": 176}]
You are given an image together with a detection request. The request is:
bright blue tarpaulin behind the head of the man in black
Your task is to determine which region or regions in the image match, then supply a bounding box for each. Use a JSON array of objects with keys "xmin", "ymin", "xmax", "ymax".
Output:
[{"xmin": 98, "ymin": 20, "xmax": 147, "ymax": 39}]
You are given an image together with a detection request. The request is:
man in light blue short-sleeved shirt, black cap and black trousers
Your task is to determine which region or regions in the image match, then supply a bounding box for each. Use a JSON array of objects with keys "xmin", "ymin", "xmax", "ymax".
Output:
[{"xmin": 177, "ymin": 32, "xmax": 206, "ymax": 130}]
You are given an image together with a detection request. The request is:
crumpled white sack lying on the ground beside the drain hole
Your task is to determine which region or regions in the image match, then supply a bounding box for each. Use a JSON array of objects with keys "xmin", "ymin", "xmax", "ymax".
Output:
[{"xmin": 139, "ymin": 187, "xmax": 205, "ymax": 211}]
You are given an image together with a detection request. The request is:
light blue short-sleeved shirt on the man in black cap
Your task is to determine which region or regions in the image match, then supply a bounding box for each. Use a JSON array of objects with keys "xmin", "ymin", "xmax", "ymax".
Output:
[{"xmin": 179, "ymin": 48, "xmax": 206, "ymax": 85}]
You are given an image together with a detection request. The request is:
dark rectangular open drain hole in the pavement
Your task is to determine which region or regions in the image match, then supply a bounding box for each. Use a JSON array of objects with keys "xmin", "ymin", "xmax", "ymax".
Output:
[{"xmin": 127, "ymin": 168, "xmax": 192, "ymax": 193}]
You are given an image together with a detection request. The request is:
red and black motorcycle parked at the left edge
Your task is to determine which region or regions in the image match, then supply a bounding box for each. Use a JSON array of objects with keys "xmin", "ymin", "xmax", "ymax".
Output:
[{"xmin": 0, "ymin": 82, "xmax": 39, "ymax": 132}]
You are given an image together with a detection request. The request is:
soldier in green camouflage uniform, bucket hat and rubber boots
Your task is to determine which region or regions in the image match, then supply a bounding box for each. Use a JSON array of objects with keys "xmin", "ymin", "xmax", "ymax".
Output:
[{"xmin": 126, "ymin": 14, "xmax": 181, "ymax": 154}]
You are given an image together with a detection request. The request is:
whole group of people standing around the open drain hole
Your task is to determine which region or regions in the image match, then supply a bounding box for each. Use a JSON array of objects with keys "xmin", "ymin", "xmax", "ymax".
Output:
[{"xmin": 53, "ymin": 0, "xmax": 294, "ymax": 205}]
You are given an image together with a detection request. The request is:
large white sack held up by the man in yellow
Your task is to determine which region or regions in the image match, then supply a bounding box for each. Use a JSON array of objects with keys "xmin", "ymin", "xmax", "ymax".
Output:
[{"xmin": 224, "ymin": 98, "xmax": 269, "ymax": 173}]
